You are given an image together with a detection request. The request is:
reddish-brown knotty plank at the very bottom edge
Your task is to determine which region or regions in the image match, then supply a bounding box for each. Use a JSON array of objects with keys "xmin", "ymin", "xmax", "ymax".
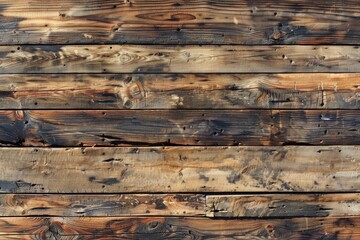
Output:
[{"xmin": 0, "ymin": 217, "xmax": 360, "ymax": 240}]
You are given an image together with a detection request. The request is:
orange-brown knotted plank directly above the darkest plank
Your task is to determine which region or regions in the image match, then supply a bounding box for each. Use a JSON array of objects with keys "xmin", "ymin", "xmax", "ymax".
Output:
[{"xmin": 0, "ymin": 73, "xmax": 360, "ymax": 109}]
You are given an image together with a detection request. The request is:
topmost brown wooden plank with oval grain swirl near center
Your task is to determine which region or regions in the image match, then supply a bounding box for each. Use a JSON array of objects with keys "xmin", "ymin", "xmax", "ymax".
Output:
[{"xmin": 0, "ymin": 0, "xmax": 360, "ymax": 44}]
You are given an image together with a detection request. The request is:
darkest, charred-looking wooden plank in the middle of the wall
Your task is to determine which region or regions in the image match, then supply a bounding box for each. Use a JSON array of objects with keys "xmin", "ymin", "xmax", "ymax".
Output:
[{"xmin": 0, "ymin": 110, "xmax": 360, "ymax": 146}]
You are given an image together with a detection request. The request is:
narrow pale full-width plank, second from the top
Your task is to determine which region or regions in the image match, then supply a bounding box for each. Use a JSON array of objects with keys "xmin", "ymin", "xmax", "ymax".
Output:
[{"xmin": 0, "ymin": 45, "xmax": 360, "ymax": 73}]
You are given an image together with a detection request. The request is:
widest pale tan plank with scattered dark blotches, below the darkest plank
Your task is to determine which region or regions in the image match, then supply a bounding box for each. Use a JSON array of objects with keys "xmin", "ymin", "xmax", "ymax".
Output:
[{"xmin": 0, "ymin": 146, "xmax": 360, "ymax": 193}]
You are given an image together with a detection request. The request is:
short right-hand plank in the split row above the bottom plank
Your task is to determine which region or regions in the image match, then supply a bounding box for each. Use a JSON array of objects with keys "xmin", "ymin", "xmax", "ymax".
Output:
[{"xmin": 206, "ymin": 193, "xmax": 360, "ymax": 218}]
